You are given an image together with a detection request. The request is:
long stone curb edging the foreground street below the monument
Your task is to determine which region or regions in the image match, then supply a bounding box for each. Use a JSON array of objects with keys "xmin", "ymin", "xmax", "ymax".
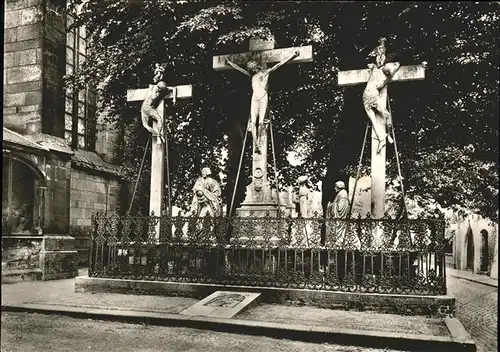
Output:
[{"xmin": 2, "ymin": 304, "xmax": 476, "ymax": 352}]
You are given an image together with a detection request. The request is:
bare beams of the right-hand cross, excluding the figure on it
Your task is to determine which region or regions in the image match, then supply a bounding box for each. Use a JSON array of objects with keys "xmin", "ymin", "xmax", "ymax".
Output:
[{"xmin": 338, "ymin": 57, "xmax": 425, "ymax": 219}]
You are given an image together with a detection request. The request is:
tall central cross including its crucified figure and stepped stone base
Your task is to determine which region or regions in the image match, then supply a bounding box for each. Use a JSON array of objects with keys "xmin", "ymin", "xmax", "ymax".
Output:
[{"xmin": 213, "ymin": 38, "xmax": 313, "ymax": 217}]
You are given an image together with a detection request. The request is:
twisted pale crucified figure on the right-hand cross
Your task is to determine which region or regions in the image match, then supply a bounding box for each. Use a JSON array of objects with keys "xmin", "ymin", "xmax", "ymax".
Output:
[{"xmin": 363, "ymin": 38, "xmax": 400, "ymax": 153}]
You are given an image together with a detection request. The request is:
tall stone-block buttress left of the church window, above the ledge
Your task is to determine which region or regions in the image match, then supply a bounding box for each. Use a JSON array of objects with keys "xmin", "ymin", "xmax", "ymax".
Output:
[{"xmin": 3, "ymin": 0, "xmax": 66, "ymax": 137}]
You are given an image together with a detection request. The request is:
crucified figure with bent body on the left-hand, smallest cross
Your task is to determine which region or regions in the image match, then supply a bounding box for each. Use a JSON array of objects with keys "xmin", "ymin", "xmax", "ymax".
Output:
[{"xmin": 141, "ymin": 81, "xmax": 169, "ymax": 143}]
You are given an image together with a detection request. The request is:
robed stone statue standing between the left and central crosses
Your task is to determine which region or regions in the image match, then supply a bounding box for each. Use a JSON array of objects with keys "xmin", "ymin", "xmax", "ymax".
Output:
[{"xmin": 191, "ymin": 167, "xmax": 222, "ymax": 217}]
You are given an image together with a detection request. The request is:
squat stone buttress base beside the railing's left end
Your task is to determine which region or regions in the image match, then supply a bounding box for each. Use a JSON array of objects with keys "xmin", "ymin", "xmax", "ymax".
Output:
[{"xmin": 40, "ymin": 235, "xmax": 78, "ymax": 280}]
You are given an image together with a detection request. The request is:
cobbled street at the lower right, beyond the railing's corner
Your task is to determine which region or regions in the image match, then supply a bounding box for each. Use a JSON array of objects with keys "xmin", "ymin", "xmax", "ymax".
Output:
[{"xmin": 447, "ymin": 277, "xmax": 498, "ymax": 352}]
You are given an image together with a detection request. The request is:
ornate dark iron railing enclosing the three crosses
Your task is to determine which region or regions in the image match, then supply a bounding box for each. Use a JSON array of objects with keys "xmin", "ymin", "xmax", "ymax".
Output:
[{"xmin": 89, "ymin": 213, "xmax": 446, "ymax": 295}]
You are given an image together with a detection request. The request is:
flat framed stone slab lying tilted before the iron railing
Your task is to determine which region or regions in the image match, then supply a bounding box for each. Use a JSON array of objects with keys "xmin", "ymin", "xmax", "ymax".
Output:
[{"xmin": 180, "ymin": 291, "xmax": 260, "ymax": 318}]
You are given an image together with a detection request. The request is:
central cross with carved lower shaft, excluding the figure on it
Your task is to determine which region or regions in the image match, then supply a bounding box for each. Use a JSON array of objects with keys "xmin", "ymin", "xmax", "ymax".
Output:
[{"xmin": 213, "ymin": 38, "xmax": 313, "ymax": 212}]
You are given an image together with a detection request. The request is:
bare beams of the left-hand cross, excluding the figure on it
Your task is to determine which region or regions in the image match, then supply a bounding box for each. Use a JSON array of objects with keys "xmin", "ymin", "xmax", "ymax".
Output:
[{"xmin": 127, "ymin": 85, "xmax": 193, "ymax": 239}]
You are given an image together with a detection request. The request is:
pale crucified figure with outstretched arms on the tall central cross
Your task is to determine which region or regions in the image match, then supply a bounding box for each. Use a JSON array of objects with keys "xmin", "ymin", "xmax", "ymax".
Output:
[{"xmin": 226, "ymin": 51, "xmax": 300, "ymax": 152}]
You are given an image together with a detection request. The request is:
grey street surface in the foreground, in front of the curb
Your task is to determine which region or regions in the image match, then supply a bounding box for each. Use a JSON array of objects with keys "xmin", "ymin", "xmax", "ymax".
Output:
[{"xmin": 1, "ymin": 312, "xmax": 397, "ymax": 352}]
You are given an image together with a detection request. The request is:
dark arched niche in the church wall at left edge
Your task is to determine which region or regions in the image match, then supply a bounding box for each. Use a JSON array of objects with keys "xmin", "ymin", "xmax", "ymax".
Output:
[{"xmin": 2, "ymin": 151, "xmax": 45, "ymax": 235}]
